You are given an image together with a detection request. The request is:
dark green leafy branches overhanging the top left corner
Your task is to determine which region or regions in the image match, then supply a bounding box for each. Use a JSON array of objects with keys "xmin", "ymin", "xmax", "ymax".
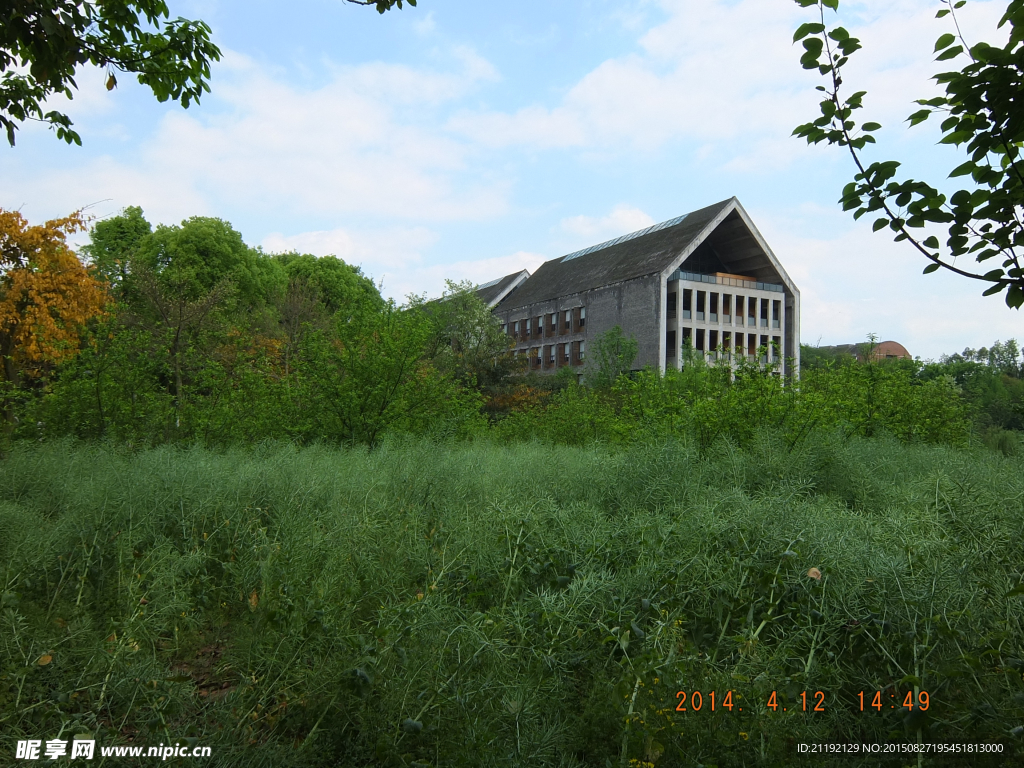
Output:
[{"xmin": 0, "ymin": 0, "xmax": 416, "ymax": 146}]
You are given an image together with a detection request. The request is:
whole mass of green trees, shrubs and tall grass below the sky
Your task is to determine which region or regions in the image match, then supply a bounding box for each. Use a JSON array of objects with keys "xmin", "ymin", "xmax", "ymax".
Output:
[{"xmin": 0, "ymin": 209, "xmax": 1024, "ymax": 768}]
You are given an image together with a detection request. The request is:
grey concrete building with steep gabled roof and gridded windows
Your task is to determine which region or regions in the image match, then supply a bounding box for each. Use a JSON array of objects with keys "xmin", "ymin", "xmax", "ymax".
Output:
[{"xmin": 477, "ymin": 198, "xmax": 800, "ymax": 376}]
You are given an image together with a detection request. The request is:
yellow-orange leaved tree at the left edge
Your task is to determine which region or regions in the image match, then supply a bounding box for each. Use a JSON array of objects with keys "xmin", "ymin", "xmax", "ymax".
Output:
[{"xmin": 0, "ymin": 209, "xmax": 105, "ymax": 429}]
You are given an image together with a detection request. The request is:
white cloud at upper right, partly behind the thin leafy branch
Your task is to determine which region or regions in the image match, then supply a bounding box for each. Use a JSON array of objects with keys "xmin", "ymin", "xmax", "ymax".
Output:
[{"xmin": 449, "ymin": 0, "xmax": 1001, "ymax": 167}]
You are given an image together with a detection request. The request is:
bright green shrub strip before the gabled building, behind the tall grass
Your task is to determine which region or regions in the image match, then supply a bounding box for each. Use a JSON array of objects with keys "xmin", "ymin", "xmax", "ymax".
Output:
[{"xmin": 498, "ymin": 348, "xmax": 972, "ymax": 450}]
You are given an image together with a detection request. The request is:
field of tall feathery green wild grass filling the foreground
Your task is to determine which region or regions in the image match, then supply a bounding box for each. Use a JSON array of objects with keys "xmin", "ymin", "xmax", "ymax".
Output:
[{"xmin": 0, "ymin": 433, "xmax": 1024, "ymax": 768}]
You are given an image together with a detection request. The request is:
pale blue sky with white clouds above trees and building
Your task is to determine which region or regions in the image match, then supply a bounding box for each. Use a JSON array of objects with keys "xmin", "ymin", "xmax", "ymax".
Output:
[{"xmin": 0, "ymin": 0, "xmax": 1024, "ymax": 359}]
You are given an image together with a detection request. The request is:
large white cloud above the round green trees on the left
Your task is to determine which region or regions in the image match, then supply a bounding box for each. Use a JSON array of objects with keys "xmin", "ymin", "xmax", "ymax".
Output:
[{"xmin": 0, "ymin": 48, "xmax": 508, "ymax": 227}]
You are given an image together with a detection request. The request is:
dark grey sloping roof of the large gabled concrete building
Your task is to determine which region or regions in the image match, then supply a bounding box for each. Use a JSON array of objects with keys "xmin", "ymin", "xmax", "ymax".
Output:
[{"xmin": 495, "ymin": 198, "xmax": 735, "ymax": 309}]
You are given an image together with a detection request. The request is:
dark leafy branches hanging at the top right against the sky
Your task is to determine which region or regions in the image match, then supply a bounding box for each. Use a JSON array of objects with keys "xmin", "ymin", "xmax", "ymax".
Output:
[{"xmin": 794, "ymin": 0, "xmax": 1024, "ymax": 308}]
